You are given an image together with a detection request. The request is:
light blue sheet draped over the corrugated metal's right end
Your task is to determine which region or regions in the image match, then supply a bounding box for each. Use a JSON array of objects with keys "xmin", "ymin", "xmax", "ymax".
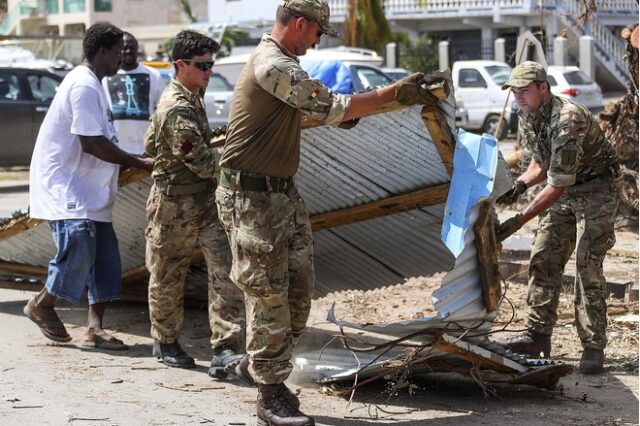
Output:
[{"xmin": 441, "ymin": 129, "xmax": 498, "ymax": 258}]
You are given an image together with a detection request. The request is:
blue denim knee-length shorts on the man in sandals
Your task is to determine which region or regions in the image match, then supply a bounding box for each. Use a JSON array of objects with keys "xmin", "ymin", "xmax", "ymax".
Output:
[{"xmin": 45, "ymin": 219, "xmax": 122, "ymax": 305}]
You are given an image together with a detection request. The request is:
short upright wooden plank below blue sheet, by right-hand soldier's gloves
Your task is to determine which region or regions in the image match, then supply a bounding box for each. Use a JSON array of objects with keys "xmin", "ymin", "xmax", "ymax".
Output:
[{"xmin": 473, "ymin": 200, "xmax": 502, "ymax": 312}]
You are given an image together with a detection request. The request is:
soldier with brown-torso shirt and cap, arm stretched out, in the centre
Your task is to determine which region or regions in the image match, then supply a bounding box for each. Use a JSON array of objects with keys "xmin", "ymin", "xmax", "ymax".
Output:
[{"xmin": 216, "ymin": 0, "xmax": 435, "ymax": 425}]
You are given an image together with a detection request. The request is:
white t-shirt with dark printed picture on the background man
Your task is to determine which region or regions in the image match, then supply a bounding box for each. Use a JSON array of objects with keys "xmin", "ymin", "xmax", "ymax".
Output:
[{"xmin": 102, "ymin": 64, "xmax": 164, "ymax": 155}]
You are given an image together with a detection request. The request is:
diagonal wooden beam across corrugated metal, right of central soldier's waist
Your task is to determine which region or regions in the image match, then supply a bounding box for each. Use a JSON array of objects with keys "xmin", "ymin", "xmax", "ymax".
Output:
[{"xmin": 310, "ymin": 183, "xmax": 449, "ymax": 231}]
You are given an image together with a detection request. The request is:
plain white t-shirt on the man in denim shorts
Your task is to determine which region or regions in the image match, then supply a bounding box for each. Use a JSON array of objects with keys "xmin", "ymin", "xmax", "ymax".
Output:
[{"xmin": 29, "ymin": 65, "xmax": 120, "ymax": 222}]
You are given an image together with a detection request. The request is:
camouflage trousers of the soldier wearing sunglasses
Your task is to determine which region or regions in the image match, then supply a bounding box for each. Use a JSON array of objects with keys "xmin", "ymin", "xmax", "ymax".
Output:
[{"xmin": 145, "ymin": 185, "xmax": 246, "ymax": 352}]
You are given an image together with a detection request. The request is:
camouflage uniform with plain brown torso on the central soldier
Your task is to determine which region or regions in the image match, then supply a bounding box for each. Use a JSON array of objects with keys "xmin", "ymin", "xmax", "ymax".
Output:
[{"xmin": 216, "ymin": 35, "xmax": 350, "ymax": 384}]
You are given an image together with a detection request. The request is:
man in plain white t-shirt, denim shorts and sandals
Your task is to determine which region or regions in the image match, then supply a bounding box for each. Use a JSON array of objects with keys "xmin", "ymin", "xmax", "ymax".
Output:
[{"xmin": 23, "ymin": 23, "xmax": 153, "ymax": 350}]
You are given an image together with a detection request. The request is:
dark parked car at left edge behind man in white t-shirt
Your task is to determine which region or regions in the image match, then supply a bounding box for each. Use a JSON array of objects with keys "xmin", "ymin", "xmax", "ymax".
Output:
[{"xmin": 0, "ymin": 67, "xmax": 62, "ymax": 167}]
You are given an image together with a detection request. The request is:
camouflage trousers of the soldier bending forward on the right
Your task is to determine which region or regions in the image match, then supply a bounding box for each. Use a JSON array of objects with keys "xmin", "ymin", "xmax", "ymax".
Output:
[{"xmin": 527, "ymin": 179, "xmax": 618, "ymax": 349}]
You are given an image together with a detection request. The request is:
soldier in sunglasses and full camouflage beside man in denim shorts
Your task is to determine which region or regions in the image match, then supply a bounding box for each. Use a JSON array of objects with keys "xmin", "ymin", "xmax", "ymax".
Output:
[{"xmin": 145, "ymin": 31, "xmax": 245, "ymax": 378}]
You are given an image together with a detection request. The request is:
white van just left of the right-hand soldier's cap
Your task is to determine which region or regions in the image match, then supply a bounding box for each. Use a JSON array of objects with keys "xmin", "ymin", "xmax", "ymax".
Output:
[{"xmin": 452, "ymin": 60, "xmax": 511, "ymax": 139}]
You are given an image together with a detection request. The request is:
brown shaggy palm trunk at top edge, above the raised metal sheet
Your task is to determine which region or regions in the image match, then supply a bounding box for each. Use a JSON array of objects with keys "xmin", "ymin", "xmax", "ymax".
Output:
[{"xmin": 344, "ymin": 0, "xmax": 391, "ymax": 52}]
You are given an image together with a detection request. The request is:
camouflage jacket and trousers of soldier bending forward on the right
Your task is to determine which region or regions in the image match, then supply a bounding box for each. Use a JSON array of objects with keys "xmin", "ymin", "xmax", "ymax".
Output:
[{"xmin": 519, "ymin": 96, "xmax": 618, "ymax": 349}]
